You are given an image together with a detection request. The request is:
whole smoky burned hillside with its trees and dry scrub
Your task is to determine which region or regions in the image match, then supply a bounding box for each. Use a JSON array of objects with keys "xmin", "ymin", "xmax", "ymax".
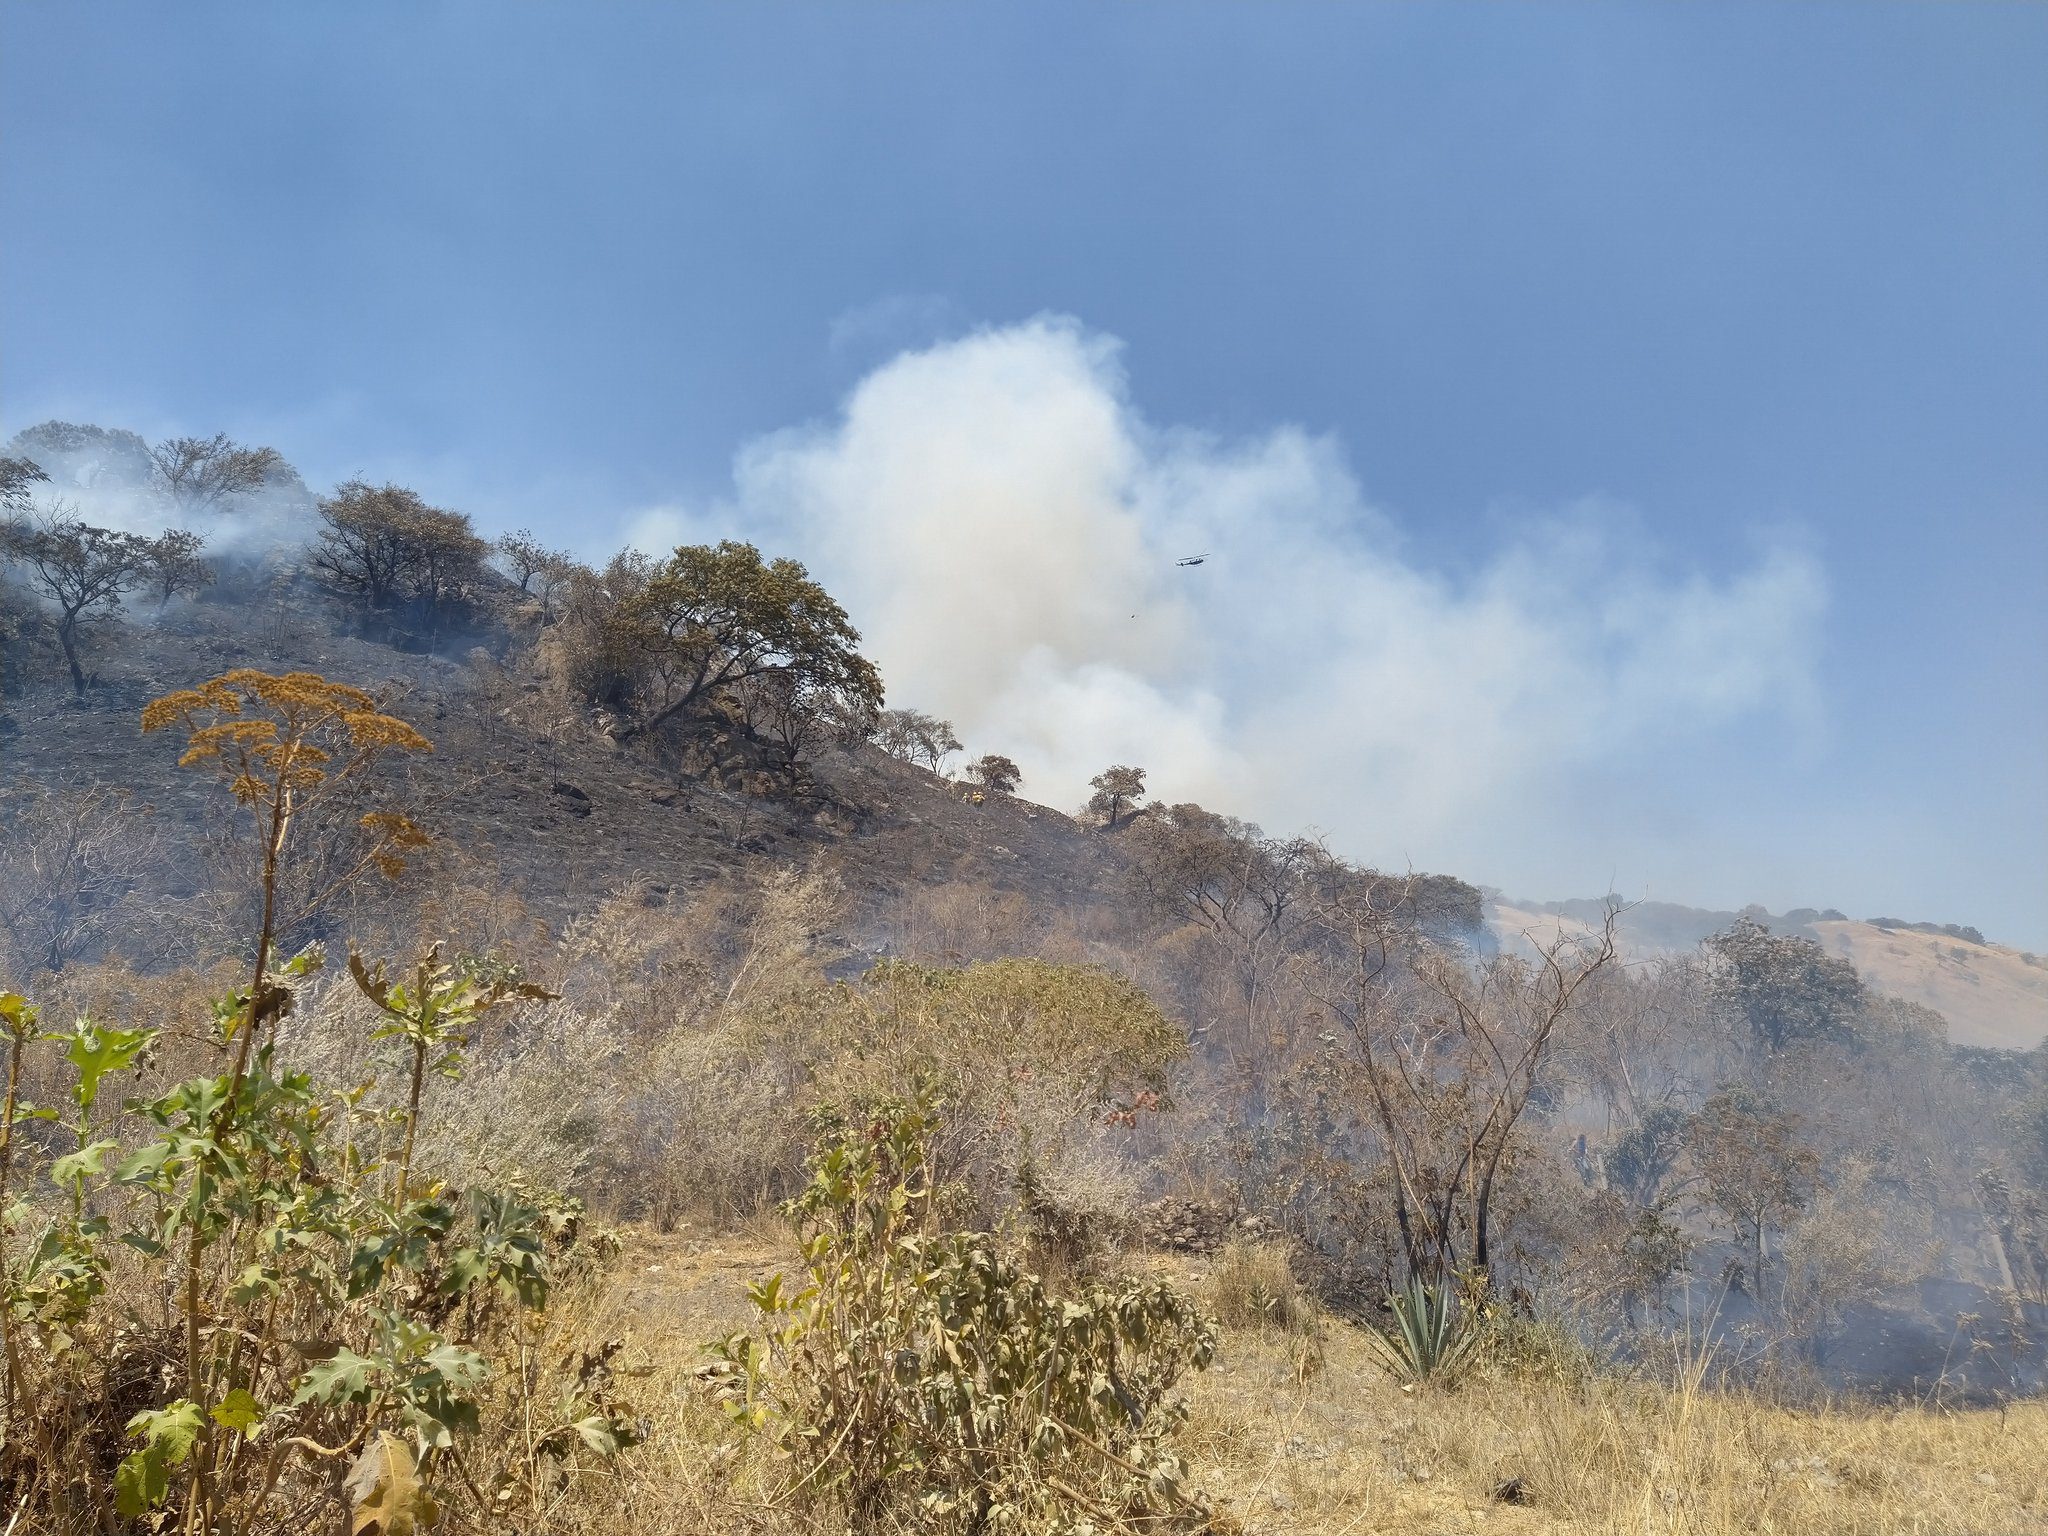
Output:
[{"xmin": 0, "ymin": 428, "xmax": 2048, "ymax": 1531}]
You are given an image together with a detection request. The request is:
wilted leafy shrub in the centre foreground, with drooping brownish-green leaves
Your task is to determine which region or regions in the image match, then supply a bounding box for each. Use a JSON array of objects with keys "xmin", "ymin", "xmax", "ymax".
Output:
[{"xmin": 705, "ymin": 1100, "xmax": 1217, "ymax": 1532}]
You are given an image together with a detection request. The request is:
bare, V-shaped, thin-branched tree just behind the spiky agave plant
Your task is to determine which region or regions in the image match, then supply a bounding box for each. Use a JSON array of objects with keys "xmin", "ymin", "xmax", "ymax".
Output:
[{"xmin": 1309, "ymin": 870, "xmax": 1614, "ymax": 1282}]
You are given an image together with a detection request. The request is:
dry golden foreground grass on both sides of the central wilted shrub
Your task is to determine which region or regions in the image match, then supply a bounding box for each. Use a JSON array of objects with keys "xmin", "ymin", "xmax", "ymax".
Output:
[{"xmin": 516, "ymin": 1223, "xmax": 2048, "ymax": 1536}]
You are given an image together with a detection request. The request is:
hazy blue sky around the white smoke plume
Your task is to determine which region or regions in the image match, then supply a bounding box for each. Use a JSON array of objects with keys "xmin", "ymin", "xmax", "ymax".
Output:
[{"xmin": 0, "ymin": 0, "xmax": 2048, "ymax": 948}]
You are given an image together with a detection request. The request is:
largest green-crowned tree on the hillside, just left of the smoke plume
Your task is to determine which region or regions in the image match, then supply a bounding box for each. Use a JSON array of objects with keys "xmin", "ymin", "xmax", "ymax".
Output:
[{"xmin": 621, "ymin": 539, "xmax": 883, "ymax": 737}]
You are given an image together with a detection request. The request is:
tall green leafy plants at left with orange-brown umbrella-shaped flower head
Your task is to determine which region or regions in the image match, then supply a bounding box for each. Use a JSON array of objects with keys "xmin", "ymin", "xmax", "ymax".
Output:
[{"xmin": 0, "ymin": 672, "xmax": 637, "ymax": 1536}]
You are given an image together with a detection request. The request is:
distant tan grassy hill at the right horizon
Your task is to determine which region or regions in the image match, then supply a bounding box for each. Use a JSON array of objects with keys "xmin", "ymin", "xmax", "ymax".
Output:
[{"xmin": 1487, "ymin": 899, "xmax": 2048, "ymax": 1051}]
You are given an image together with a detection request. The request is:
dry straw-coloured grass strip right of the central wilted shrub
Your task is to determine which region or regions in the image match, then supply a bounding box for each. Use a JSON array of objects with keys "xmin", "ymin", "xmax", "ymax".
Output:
[{"xmin": 1190, "ymin": 1329, "xmax": 2048, "ymax": 1536}]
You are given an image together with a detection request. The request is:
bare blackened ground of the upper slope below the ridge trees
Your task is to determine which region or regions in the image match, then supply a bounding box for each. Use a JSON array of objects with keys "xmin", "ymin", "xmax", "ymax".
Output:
[{"xmin": 0, "ymin": 581, "xmax": 1120, "ymax": 937}]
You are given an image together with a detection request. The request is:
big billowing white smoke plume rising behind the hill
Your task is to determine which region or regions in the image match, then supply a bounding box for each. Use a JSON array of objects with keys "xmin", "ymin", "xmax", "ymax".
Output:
[{"xmin": 631, "ymin": 317, "xmax": 1825, "ymax": 866}]
